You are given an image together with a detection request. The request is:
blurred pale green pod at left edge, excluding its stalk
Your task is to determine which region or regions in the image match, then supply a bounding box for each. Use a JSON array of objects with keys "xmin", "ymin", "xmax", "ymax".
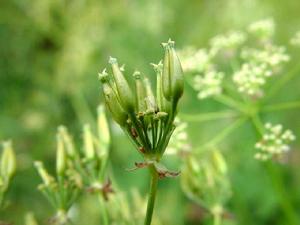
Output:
[{"xmin": 0, "ymin": 141, "xmax": 17, "ymax": 180}]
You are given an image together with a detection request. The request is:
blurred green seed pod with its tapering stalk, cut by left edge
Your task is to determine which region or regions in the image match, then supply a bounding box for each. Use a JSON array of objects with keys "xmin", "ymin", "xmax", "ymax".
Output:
[{"xmin": 0, "ymin": 141, "xmax": 17, "ymax": 210}]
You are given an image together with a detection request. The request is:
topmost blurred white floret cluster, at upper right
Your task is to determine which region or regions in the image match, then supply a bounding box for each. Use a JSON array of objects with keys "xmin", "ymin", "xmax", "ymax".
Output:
[{"xmin": 248, "ymin": 18, "xmax": 275, "ymax": 40}]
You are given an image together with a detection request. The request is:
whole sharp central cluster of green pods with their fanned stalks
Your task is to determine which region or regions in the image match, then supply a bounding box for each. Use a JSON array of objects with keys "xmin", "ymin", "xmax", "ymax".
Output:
[{"xmin": 99, "ymin": 40, "xmax": 184, "ymax": 168}]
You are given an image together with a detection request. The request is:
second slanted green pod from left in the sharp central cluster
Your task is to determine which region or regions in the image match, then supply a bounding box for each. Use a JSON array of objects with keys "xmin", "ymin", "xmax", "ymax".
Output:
[{"xmin": 109, "ymin": 57, "xmax": 135, "ymax": 113}]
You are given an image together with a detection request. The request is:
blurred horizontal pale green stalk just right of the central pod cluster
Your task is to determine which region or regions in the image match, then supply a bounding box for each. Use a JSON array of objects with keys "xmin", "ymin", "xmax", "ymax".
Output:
[{"xmin": 179, "ymin": 110, "xmax": 238, "ymax": 122}]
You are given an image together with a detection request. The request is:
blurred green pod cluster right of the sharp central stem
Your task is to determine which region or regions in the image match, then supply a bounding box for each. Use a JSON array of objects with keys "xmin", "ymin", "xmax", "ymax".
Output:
[{"xmin": 181, "ymin": 150, "xmax": 231, "ymax": 219}]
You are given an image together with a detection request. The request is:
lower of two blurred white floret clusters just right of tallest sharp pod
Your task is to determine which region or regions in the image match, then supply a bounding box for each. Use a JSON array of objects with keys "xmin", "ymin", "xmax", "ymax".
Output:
[{"xmin": 194, "ymin": 69, "xmax": 224, "ymax": 99}]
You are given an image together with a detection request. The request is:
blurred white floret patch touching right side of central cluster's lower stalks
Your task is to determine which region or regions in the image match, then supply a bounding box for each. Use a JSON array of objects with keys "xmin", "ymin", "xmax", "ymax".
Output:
[{"xmin": 166, "ymin": 118, "xmax": 190, "ymax": 155}]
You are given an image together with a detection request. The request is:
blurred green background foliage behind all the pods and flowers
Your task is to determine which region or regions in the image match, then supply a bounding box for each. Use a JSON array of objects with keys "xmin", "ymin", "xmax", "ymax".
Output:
[{"xmin": 0, "ymin": 0, "xmax": 300, "ymax": 225}]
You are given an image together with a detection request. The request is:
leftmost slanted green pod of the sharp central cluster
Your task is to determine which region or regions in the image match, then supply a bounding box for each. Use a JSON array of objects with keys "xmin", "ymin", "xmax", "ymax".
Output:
[{"xmin": 99, "ymin": 70, "xmax": 128, "ymax": 127}]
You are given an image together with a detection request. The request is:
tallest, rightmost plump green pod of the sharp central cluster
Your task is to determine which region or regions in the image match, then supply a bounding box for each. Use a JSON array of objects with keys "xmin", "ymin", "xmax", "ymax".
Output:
[{"xmin": 162, "ymin": 40, "xmax": 184, "ymax": 102}]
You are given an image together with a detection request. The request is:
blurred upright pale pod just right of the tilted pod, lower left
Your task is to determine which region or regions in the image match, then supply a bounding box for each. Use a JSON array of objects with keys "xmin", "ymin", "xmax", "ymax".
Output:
[{"xmin": 56, "ymin": 133, "xmax": 67, "ymax": 176}]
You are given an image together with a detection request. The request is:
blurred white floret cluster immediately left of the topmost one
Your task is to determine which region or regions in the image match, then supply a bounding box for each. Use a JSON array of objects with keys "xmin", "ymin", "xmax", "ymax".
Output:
[{"xmin": 210, "ymin": 31, "xmax": 246, "ymax": 55}]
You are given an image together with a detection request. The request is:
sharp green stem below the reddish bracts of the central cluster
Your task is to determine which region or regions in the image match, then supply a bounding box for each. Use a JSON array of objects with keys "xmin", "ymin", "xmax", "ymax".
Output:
[{"xmin": 144, "ymin": 165, "xmax": 158, "ymax": 225}]
